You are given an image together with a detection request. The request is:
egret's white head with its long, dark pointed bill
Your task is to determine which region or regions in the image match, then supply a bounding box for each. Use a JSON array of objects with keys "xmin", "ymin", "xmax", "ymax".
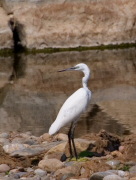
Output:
[{"xmin": 59, "ymin": 63, "xmax": 90, "ymax": 72}]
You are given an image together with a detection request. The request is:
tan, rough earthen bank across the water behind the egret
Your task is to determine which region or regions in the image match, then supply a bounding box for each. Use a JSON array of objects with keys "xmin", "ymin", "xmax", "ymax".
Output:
[{"xmin": 0, "ymin": 0, "xmax": 136, "ymax": 49}]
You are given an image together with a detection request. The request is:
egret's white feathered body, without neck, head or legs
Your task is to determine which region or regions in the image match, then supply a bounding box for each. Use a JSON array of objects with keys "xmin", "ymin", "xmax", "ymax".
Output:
[{"xmin": 49, "ymin": 88, "xmax": 90, "ymax": 135}]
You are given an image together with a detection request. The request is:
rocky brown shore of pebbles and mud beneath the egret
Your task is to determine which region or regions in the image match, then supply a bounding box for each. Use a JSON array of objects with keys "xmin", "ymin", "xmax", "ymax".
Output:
[{"xmin": 0, "ymin": 130, "xmax": 136, "ymax": 180}]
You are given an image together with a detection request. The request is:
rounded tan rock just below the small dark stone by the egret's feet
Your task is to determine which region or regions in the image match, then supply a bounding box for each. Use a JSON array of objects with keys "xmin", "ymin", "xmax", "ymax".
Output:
[{"xmin": 38, "ymin": 159, "xmax": 64, "ymax": 172}]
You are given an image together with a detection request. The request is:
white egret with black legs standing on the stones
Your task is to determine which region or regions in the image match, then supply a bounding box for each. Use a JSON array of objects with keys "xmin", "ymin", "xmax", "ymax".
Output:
[{"xmin": 49, "ymin": 63, "xmax": 91, "ymax": 159}]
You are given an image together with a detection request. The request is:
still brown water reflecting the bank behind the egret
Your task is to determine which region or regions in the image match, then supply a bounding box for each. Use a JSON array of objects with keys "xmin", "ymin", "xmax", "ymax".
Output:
[{"xmin": 0, "ymin": 48, "xmax": 136, "ymax": 137}]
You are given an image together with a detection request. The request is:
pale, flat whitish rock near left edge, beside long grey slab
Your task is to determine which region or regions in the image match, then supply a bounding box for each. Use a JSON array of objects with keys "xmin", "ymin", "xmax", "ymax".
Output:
[{"xmin": 3, "ymin": 143, "xmax": 28, "ymax": 154}]
